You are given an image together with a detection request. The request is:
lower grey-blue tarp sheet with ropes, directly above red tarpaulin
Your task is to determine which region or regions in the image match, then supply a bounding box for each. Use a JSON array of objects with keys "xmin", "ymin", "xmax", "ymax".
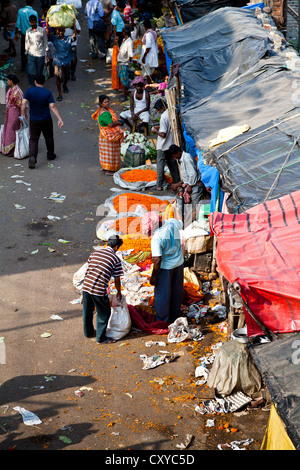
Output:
[{"xmin": 204, "ymin": 108, "xmax": 300, "ymax": 213}]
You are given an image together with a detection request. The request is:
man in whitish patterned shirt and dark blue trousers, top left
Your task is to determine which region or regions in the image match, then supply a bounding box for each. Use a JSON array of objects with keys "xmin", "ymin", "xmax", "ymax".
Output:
[{"xmin": 25, "ymin": 15, "xmax": 49, "ymax": 86}]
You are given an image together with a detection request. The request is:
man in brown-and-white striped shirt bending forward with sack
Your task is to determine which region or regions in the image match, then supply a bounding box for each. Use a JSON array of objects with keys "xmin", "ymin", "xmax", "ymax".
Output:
[{"xmin": 82, "ymin": 235, "xmax": 123, "ymax": 343}]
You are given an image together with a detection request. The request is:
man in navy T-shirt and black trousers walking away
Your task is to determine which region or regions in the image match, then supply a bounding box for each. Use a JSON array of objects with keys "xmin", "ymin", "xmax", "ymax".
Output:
[{"xmin": 21, "ymin": 75, "xmax": 64, "ymax": 169}]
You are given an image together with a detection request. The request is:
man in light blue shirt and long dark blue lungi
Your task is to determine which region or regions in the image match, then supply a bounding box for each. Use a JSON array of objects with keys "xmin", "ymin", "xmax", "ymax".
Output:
[{"xmin": 150, "ymin": 219, "xmax": 184, "ymax": 323}]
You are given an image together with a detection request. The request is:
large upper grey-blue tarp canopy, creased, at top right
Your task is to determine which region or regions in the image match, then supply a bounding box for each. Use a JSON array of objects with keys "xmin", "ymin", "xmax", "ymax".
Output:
[{"xmin": 161, "ymin": 7, "xmax": 300, "ymax": 150}]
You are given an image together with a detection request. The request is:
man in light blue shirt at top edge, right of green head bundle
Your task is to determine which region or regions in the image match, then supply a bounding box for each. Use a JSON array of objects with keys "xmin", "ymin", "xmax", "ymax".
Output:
[{"xmin": 85, "ymin": 0, "xmax": 106, "ymax": 60}]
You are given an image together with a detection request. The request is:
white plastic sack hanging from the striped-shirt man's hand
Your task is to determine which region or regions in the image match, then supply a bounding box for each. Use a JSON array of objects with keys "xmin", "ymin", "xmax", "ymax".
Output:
[{"xmin": 106, "ymin": 296, "xmax": 131, "ymax": 341}]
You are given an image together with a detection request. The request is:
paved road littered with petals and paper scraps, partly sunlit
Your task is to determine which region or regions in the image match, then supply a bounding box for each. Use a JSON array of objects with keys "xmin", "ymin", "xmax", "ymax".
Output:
[{"xmin": 0, "ymin": 1, "xmax": 268, "ymax": 451}]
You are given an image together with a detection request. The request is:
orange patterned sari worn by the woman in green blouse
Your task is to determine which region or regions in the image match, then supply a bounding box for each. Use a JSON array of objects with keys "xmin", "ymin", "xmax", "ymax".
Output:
[{"xmin": 92, "ymin": 108, "xmax": 124, "ymax": 171}]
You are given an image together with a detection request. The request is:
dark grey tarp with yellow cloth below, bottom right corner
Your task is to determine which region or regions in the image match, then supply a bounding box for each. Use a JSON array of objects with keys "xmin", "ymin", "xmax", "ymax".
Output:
[{"xmin": 249, "ymin": 334, "xmax": 300, "ymax": 450}]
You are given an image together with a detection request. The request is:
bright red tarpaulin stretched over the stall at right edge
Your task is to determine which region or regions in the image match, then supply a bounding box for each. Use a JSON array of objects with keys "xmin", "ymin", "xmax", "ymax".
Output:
[{"xmin": 209, "ymin": 191, "xmax": 300, "ymax": 337}]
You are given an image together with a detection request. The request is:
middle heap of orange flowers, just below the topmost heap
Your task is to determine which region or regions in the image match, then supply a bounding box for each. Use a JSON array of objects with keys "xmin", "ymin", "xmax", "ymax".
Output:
[{"xmin": 113, "ymin": 193, "xmax": 169, "ymax": 214}]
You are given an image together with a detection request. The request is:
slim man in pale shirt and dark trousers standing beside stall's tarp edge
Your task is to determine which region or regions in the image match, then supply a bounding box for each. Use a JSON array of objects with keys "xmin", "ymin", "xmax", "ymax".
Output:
[{"xmin": 151, "ymin": 99, "xmax": 180, "ymax": 191}]
